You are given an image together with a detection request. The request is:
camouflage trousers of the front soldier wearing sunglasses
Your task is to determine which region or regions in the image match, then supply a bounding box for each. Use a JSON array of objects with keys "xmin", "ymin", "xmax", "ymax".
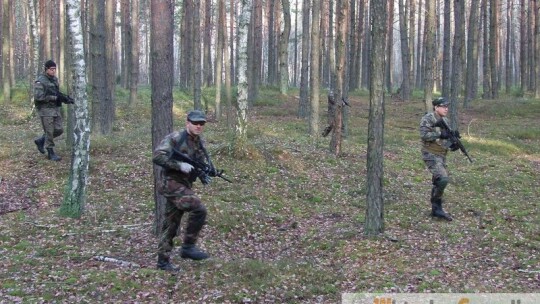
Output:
[{"xmin": 158, "ymin": 179, "xmax": 206, "ymax": 258}]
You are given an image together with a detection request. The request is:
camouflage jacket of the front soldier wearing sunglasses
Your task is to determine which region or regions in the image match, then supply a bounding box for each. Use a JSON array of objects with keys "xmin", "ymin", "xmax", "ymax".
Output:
[{"xmin": 153, "ymin": 130, "xmax": 206, "ymax": 188}]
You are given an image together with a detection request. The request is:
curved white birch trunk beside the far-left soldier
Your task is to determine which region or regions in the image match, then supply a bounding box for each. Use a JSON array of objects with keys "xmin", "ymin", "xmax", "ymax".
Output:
[{"xmin": 60, "ymin": 0, "xmax": 90, "ymax": 218}]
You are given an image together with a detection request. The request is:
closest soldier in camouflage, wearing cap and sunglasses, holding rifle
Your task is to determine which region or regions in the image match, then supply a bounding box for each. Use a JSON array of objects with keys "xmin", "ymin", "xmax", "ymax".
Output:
[{"xmin": 153, "ymin": 110, "xmax": 211, "ymax": 271}]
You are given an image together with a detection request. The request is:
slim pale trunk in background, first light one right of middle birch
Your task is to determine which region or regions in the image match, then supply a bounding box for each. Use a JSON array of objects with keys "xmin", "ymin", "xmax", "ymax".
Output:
[{"xmin": 279, "ymin": 0, "xmax": 291, "ymax": 95}]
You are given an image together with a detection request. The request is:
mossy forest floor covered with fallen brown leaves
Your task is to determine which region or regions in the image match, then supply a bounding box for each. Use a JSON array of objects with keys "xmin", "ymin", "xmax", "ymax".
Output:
[{"xmin": 0, "ymin": 86, "xmax": 540, "ymax": 303}]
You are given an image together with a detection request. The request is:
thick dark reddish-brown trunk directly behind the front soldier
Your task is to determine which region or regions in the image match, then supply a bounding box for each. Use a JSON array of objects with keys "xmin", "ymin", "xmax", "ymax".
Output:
[{"xmin": 150, "ymin": 0, "xmax": 174, "ymax": 234}]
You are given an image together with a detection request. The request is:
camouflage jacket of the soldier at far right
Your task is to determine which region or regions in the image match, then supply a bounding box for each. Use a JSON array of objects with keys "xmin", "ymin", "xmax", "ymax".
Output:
[{"xmin": 420, "ymin": 112, "xmax": 451, "ymax": 156}]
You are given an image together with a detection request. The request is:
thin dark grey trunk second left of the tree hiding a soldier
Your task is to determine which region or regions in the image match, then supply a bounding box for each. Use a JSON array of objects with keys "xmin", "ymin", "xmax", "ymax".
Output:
[{"xmin": 298, "ymin": 0, "xmax": 310, "ymax": 118}]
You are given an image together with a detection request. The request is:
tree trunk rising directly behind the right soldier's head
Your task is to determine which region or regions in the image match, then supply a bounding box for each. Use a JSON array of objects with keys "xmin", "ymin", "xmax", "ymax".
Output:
[{"xmin": 424, "ymin": 1, "xmax": 437, "ymax": 113}]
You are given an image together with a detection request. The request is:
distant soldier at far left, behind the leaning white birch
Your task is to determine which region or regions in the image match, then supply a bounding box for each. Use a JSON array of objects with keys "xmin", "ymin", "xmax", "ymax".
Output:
[{"xmin": 34, "ymin": 60, "xmax": 72, "ymax": 161}]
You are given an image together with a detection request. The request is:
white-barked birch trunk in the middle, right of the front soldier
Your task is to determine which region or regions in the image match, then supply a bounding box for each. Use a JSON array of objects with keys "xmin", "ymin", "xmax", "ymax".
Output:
[{"xmin": 234, "ymin": 0, "xmax": 253, "ymax": 155}]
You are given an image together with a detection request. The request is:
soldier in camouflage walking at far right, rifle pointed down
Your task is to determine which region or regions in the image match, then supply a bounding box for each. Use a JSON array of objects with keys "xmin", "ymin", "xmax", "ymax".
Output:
[{"xmin": 420, "ymin": 97, "xmax": 460, "ymax": 221}]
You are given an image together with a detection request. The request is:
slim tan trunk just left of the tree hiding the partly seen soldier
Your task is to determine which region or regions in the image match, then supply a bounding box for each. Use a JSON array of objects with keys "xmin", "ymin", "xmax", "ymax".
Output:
[{"xmin": 309, "ymin": 0, "xmax": 322, "ymax": 137}]
